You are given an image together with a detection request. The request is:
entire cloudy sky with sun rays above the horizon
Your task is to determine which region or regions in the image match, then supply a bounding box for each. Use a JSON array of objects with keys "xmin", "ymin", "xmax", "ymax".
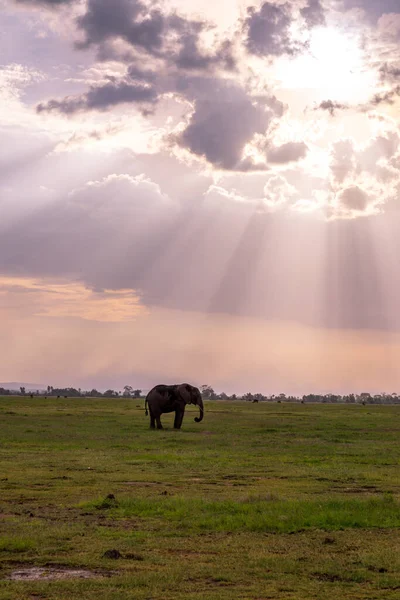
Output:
[{"xmin": 0, "ymin": 0, "xmax": 400, "ymax": 395}]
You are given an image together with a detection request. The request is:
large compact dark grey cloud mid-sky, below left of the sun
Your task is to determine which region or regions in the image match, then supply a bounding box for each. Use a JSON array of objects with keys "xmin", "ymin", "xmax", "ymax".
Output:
[{"xmin": 178, "ymin": 78, "xmax": 283, "ymax": 170}]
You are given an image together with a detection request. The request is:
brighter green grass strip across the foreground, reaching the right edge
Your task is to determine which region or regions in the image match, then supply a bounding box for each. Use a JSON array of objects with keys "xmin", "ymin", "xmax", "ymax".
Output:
[{"xmin": 85, "ymin": 496, "xmax": 400, "ymax": 534}]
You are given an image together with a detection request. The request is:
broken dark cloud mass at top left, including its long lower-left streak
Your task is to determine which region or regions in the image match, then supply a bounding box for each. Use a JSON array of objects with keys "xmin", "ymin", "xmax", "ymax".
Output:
[{"xmin": 37, "ymin": 0, "xmax": 235, "ymax": 119}]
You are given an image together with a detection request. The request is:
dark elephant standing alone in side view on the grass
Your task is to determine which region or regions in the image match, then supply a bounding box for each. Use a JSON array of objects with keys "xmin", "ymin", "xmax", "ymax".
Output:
[{"xmin": 144, "ymin": 383, "xmax": 204, "ymax": 429}]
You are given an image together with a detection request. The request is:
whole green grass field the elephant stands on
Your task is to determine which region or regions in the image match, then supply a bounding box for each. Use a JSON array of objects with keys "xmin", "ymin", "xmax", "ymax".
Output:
[{"xmin": 0, "ymin": 397, "xmax": 400, "ymax": 600}]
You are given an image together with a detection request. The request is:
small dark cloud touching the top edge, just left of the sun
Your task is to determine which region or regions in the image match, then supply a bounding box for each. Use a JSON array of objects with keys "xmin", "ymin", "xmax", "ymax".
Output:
[{"xmin": 244, "ymin": 2, "xmax": 298, "ymax": 56}]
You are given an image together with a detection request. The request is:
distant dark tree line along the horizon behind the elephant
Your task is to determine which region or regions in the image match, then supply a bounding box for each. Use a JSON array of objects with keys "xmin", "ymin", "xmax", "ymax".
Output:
[{"xmin": 0, "ymin": 385, "xmax": 400, "ymax": 404}]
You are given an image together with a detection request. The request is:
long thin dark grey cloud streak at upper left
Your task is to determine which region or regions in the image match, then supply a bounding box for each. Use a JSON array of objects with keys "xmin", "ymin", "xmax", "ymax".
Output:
[{"xmin": 36, "ymin": 81, "xmax": 157, "ymax": 114}]
